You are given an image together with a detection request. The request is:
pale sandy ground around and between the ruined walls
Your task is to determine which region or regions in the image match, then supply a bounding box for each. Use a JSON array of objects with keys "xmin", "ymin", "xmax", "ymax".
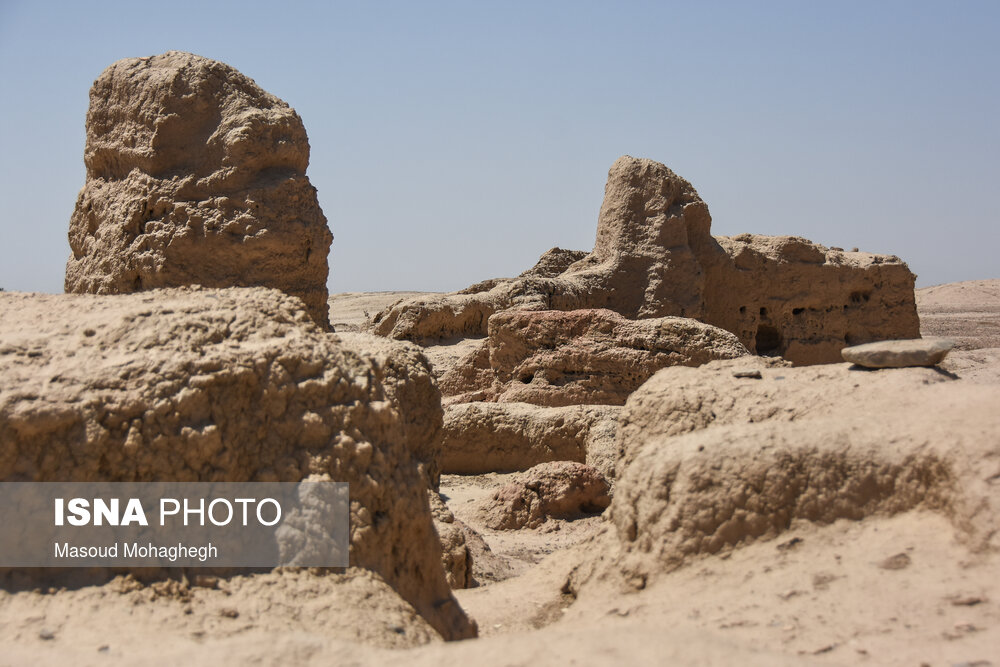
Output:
[{"xmin": 0, "ymin": 280, "xmax": 1000, "ymax": 667}]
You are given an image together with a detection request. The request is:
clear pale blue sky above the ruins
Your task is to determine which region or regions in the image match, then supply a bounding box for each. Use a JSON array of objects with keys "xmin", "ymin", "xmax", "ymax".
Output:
[{"xmin": 0, "ymin": 0, "xmax": 1000, "ymax": 292}]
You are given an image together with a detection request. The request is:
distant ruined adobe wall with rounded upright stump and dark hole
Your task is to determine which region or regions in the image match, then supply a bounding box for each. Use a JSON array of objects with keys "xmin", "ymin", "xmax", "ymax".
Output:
[{"xmin": 373, "ymin": 156, "xmax": 919, "ymax": 364}]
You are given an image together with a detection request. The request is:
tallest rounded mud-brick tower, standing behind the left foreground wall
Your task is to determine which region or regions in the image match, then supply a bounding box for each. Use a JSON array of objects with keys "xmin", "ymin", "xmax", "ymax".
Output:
[{"xmin": 65, "ymin": 51, "xmax": 333, "ymax": 327}]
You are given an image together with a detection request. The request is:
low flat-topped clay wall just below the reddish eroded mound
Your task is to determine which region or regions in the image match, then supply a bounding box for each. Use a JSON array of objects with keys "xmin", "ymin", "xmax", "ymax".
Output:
[{"xmin": 440, "ymin": 402, "xmax": 621, "ymax": 475}]
